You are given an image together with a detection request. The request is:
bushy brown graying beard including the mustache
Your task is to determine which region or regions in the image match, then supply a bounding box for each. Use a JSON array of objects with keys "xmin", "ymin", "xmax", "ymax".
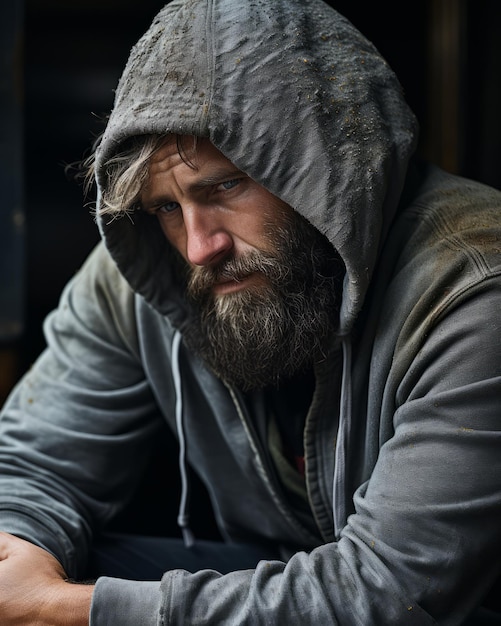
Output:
[{"xmin": 185, "ymin": 212, "xmax": 344, "ymax": 391}]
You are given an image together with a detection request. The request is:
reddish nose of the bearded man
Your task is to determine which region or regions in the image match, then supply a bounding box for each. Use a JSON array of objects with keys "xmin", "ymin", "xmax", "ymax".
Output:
[{"xmin": 183, "ymin": 206, "xmax": 233, "ymax": 265}]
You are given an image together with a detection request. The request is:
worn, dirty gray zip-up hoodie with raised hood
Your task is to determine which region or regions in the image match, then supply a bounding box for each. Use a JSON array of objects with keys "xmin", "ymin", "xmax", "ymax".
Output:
[{"xmin": 0, "ymin": 0, "xmax": 501, "ymax": 626}]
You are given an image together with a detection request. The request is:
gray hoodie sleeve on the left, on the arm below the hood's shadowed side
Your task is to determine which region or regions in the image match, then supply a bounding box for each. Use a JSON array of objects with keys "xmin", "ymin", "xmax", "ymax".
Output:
[{"xmin": 0, "ymin": 240, "xmax": 161, "ymax": 576}]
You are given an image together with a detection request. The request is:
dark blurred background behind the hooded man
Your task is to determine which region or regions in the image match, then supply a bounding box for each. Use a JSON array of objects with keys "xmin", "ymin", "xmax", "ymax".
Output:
[{"xmin": 0, "ymin": 0, "xmax": 501, "ymax": 532}]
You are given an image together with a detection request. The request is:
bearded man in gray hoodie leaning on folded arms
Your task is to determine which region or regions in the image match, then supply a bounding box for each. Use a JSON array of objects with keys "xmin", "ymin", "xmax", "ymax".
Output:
[{"xmin": 0, "ymin": 0, "xmax": 501, "ymax": 626}]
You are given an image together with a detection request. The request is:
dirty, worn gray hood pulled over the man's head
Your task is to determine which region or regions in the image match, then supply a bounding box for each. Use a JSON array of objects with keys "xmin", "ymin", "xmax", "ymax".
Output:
[{"xmin": 96, "ymin": 0, "xmax": 417, "ymax": 334}]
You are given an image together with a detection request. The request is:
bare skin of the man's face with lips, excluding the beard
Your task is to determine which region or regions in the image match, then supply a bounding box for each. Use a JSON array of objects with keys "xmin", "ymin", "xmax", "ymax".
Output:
[{"xmin": 141, "ymin": 138, "xmax": 292, "ymax": 296}]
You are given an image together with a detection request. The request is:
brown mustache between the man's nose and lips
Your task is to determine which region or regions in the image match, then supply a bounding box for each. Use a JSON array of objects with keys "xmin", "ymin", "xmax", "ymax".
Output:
[{"xmin": 187, "ymin": 251, "xmax": 283, "ymax": 299}]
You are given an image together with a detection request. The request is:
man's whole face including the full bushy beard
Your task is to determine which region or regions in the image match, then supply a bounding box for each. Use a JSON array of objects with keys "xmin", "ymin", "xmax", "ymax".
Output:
[{"xmin": 141, "ymin": 138, "xmax": 344, "ymax": 390}]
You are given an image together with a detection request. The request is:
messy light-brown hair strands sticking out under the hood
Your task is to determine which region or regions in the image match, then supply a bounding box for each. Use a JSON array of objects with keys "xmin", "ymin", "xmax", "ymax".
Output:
[{"xmin": 81, "ymin": 135, "xmax": 197, "ymax": 217}]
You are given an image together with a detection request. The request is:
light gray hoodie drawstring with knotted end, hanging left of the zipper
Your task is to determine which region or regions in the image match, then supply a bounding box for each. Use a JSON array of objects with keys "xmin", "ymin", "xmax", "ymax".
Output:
[{"xmin": 172, "ymin": 331, "xmax": 195, "ymax": 548}]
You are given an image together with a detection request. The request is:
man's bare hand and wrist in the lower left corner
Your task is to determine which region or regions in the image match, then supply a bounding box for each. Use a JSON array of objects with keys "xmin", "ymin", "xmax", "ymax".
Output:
[{"xmin": 0, "ymin": 532, "xmax": 94, "ymax": 626}]
